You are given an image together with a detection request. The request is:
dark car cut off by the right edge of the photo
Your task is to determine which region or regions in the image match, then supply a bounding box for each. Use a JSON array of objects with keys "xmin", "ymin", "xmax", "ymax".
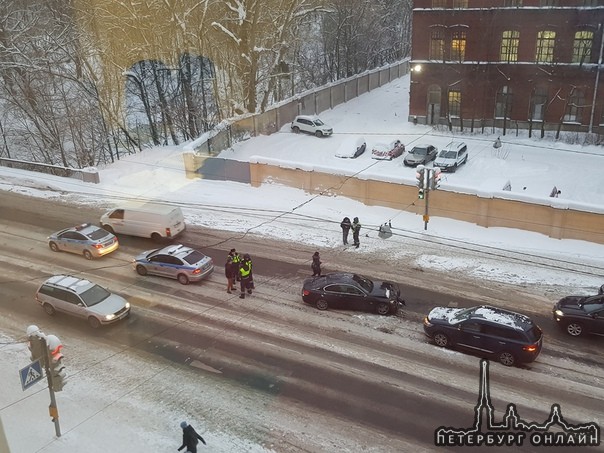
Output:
[{"xmin": 552, "ymin": 294, "xmax": 604, "ymax": 337}]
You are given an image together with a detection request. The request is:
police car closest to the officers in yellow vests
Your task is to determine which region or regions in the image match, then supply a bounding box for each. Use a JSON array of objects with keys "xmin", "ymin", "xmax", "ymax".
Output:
[{"xmin": 133, "ymin": 244, "xmax": 214, "ymax": 285}]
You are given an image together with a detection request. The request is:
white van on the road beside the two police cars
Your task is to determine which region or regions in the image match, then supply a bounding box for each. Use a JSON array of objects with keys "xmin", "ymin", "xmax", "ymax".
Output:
[{"xmin": 101, "ymin": 203, "xmax": 186, "ymax": 240}]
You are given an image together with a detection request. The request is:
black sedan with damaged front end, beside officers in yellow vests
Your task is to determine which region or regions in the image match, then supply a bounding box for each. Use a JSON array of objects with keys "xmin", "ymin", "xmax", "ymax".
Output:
[{"xmin": 302, "ymin": 273, "xmax": 405, "ymax": 315}]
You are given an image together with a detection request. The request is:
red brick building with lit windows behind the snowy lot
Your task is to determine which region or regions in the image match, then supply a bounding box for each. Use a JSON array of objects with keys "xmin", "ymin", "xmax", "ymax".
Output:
[{"xmin": 409, "ymin": 0, "xmax": 604, "ymax": 135}]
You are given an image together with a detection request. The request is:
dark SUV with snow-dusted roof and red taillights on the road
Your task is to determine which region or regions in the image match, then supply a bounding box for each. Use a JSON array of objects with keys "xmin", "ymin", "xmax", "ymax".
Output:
[{"xmin": 424, "ymin": 305, "xmax": 543, "ymax": 366}]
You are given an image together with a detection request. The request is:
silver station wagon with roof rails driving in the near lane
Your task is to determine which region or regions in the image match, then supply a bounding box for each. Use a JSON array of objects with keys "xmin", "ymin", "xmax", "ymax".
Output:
[{"xmin": 36, "ymin": 275, "xmax": 130, "ymax": 329}]
